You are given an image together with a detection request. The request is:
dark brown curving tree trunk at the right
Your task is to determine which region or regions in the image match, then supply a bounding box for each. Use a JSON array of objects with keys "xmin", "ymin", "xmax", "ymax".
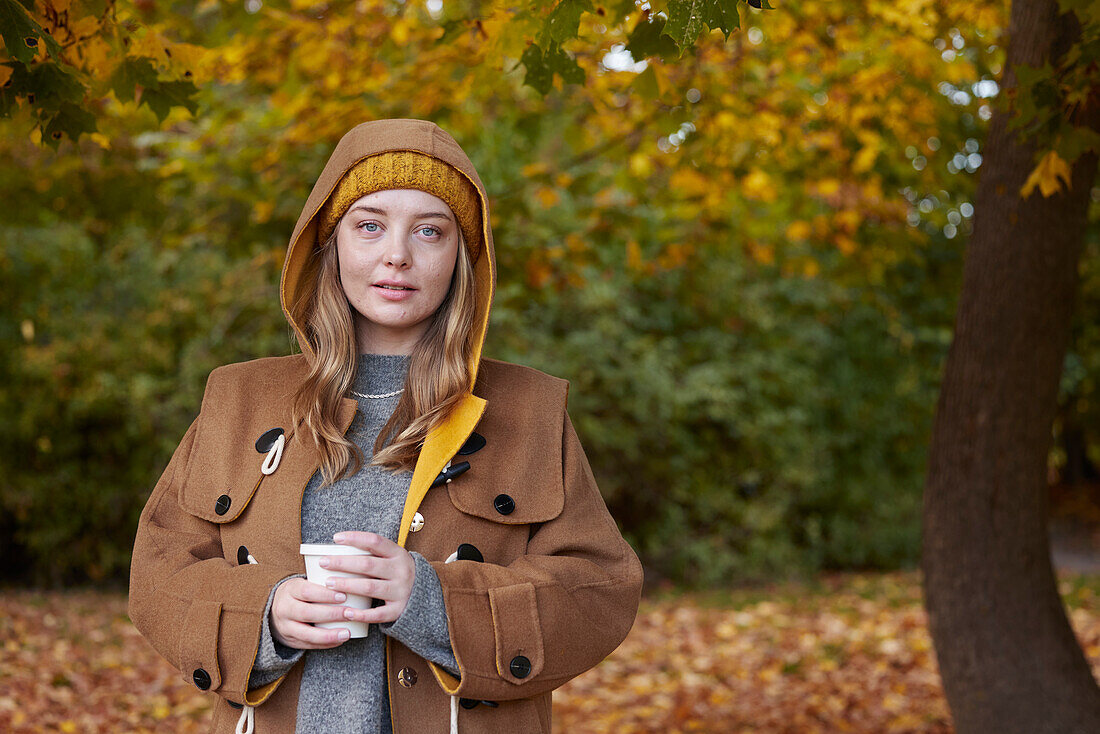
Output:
[{"xmin": 922, "ymin": 0, "xmax": 1100, "ymax": 734}]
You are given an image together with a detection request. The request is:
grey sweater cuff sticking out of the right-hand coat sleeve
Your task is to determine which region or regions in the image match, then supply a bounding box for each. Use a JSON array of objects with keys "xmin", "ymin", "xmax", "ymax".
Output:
[{"xmin": 377, "ymin": 550, "xmax": 459, "ymax": 676}]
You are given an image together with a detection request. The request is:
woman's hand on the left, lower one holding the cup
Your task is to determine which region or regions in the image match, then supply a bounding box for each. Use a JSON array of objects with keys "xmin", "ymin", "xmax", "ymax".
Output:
[{"xmin": 271, "ymin": 579, "xmax": 351, "ymax": 650}]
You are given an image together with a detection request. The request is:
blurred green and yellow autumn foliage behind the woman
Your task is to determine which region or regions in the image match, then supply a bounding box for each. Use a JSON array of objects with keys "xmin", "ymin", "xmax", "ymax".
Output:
[{"xmin": 0, "ymin": 0, "xmax": 1100, "ymax": 585}]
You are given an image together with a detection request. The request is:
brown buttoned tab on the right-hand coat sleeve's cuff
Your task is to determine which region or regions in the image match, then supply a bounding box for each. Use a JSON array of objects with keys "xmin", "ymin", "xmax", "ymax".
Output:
[{"xmin": 488, "ymin": 581, "xmax": 542, "ymax": 683}]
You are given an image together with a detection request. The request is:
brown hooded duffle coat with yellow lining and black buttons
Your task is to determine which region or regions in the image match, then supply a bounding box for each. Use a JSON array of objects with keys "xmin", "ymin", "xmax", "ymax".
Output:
[{"xmin": 129, "ymin": 120, "xmax": 642, "ymax": 734}]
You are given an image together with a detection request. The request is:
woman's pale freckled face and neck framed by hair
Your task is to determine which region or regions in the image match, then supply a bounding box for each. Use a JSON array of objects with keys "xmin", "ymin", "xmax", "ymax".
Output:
[{"xmin": 337, "ymin": 188, "xmax": 459, "ymax": 354}]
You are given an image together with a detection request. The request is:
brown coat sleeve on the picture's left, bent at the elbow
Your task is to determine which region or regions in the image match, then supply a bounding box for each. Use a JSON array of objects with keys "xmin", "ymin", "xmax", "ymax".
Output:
[{"xmin": 128, "ymin": 368, "xmax": 296, "ymax": 705}]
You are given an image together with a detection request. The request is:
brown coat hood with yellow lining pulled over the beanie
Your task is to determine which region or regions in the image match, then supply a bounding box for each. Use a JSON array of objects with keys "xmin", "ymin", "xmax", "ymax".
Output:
[{"xmin": 279, "ymin": 119, "xmax": 496, "ymax": 387}]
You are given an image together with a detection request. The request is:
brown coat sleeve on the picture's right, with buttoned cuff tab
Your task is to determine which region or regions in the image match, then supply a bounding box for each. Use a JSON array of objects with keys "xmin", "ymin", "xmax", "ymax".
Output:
[{"xmin": 430, "ymin": 413, "xmax": 642, "ymax": 701}]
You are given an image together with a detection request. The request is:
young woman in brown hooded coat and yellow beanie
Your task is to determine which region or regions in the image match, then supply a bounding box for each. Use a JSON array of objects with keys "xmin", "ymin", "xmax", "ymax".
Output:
[{"xmin": 130, "ymin": 120, "xmax": 642, "ymax": 734}]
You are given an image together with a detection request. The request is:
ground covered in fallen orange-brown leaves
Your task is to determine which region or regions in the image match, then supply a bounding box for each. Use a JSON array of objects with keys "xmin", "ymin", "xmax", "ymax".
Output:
[{"xmin": 0, "ymin": 572, "xmax": 1100, "ymax": 734}]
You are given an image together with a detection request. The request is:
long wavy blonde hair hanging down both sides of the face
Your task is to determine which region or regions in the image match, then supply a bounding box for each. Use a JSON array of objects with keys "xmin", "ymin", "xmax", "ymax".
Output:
[{"xmin": 292, "ymin": 221, "xmax": 476, "ymax": 479}]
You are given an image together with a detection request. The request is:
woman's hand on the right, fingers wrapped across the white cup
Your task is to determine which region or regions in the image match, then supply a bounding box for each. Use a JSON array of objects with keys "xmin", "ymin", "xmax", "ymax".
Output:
[{"xmin": 320, "ymin": 530, "xmax": 416, "ymax": 623}]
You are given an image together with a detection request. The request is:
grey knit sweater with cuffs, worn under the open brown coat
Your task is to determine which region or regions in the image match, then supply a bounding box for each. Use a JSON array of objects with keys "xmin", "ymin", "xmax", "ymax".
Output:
[{"xmin": 249, "ymin": 354, "xmax": 459, "ymax": 734}]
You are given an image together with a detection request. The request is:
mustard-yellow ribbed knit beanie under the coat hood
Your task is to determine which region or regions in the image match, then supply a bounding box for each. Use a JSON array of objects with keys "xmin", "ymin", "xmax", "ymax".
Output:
[{"xmin": 317, "ymin": 151, "xmax": 482, "ymax": 262}]
